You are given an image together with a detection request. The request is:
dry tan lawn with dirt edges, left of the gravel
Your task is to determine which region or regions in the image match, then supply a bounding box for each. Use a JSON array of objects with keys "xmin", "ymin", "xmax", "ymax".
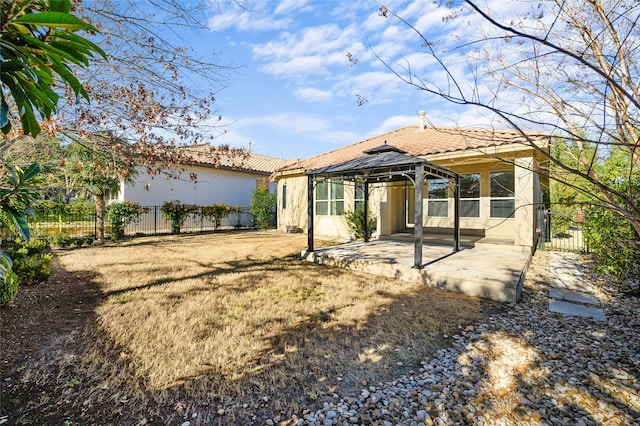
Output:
[{"xmin": 0, "ymin": 235, "xmax": 505, "ymax": 425}]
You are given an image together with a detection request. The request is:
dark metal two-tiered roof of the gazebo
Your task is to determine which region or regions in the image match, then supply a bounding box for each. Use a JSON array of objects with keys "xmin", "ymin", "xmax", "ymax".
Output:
[{"xmin": 305, "ymin": 141, "xmax": 456, "ymax": 182}]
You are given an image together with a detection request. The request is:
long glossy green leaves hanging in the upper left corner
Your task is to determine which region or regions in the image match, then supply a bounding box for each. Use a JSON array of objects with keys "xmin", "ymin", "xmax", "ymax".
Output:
[{"xmin": 0, "ymin": 0, "xmax": 106, "ymax": 136}]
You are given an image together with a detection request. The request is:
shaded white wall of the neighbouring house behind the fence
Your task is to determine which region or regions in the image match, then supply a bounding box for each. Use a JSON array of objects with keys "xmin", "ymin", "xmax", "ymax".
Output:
[{"xmin": 116, "ymin": 167, "xmax": 277, "ymax": 207}]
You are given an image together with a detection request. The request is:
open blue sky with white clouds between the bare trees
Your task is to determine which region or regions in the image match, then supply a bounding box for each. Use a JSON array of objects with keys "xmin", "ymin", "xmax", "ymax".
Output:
[{"xmin": 194, "ymin": 0, "xmax": 532, "ymax": 159}]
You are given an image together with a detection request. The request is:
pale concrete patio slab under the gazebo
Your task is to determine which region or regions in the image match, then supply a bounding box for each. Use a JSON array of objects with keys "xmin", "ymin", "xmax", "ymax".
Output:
[{"xmin": 302, "ymin": 235, "xmax": 531, "ymax": 303}]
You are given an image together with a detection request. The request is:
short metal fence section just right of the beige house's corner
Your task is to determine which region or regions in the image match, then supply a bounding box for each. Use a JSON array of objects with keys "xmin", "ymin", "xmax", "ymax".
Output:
[{"xmin": 538, "ymin": 209, "xmax": 589, "ymax": 253}]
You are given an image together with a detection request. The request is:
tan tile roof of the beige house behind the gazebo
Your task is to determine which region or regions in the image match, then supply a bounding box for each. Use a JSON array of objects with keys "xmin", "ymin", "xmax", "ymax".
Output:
[{"xmin": 276, "ymin": 126, "xmax": 545, "ymax": 172}]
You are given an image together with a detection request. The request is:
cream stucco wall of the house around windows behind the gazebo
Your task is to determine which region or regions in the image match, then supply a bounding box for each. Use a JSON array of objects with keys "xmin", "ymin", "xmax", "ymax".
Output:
[{"xmin": 278, "ymin": 150, "xmax": 540, "ymax": 247}]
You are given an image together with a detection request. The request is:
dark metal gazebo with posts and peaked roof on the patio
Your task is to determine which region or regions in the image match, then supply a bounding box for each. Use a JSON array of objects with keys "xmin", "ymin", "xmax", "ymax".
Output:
[{"xmin": 305, "ymin": 141, "xmax": 460, "ymax": 269}]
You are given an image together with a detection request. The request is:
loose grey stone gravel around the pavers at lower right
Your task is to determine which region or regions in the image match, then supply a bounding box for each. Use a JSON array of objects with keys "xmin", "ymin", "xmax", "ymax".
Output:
[{"xmin": 280, "ymin": 252, "xmax": 640, "ymax": 426}]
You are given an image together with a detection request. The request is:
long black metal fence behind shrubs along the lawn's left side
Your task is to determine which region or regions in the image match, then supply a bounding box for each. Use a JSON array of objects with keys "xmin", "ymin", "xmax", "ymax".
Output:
[{"xmin": 29, "ymin": 206, "xmax": 255, "ymax": 238}]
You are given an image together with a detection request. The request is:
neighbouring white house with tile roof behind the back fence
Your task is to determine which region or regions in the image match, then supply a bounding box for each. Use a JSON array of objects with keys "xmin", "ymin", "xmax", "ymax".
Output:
[{"xmin": 109, "ymin": 143, "xmax": 287, "ymax": 225}]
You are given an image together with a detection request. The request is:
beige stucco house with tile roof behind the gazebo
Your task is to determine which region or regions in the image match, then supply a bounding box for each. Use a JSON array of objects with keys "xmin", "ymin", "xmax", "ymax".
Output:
[{"xmin": 272, "ymin": 111, "xmax": 549, "ymax": 252}]
